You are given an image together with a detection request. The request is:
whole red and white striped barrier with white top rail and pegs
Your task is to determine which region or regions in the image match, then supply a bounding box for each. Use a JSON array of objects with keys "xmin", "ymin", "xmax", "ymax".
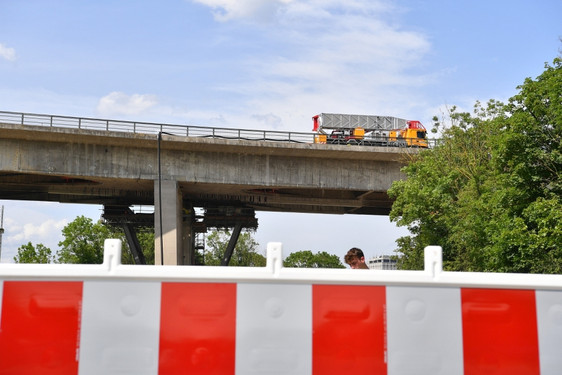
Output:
[{"xmin": 0, "ymin": 240, "xmax": 562, "ymax": 375}]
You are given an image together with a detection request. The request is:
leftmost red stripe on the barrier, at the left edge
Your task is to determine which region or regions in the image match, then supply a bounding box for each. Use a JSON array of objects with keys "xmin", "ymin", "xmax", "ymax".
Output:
[{"xmin": 0, "ymin": 281, "xmax": 82, "ymax": 375}]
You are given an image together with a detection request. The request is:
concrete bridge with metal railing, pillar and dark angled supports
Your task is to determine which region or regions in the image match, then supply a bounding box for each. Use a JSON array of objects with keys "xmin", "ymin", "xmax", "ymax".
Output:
[{"xmin": 0, "ymin": 112, "xmax": 416, "ymax": 264}]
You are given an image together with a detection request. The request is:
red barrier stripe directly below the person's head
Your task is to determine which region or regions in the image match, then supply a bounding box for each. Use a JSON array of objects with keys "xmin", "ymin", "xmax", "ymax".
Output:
[{"xmin": 312, "ymin": 285, "xmax": 387, "ymax": 375}]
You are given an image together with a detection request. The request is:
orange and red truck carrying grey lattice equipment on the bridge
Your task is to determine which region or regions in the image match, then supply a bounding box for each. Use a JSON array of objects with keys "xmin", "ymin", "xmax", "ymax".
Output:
[{"xmin": 312, "ymin": 113, "xmax": 428, "ymax": 148}]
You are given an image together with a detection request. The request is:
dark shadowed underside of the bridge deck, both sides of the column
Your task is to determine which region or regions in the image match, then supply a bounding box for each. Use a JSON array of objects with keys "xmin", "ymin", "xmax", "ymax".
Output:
[{"xmin": 0, "ymin": 173, "xmax": 392, "ymax": 215}]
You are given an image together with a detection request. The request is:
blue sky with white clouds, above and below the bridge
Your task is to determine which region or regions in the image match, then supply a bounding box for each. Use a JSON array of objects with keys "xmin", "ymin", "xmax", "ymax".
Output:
[{"xmin": 0, "ymin": 0, "xmax": 562, "ymax": 262}]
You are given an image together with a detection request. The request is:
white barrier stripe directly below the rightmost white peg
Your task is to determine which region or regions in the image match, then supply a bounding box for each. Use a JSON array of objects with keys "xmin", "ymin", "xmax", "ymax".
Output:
[{"xmin": 386, "ymin": 287, "xmax": 463, "ymax": 375}]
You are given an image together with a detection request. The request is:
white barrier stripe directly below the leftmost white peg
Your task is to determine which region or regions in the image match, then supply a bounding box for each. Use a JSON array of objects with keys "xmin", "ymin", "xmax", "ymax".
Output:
[{"xmin": 79, "ymin": 281, "xmax": 161, "ymax": 375}]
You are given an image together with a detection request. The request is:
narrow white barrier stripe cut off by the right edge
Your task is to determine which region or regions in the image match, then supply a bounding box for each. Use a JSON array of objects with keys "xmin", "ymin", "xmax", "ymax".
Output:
[{"xmin": 535, "ymin": 290, "xmax": 562, "ymax": 375}]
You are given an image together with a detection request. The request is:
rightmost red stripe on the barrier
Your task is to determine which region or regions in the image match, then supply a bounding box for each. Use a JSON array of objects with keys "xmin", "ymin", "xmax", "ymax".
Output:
[{"xmin": 461, "ymin": 288, "xmax": 540, "ymax": 375}]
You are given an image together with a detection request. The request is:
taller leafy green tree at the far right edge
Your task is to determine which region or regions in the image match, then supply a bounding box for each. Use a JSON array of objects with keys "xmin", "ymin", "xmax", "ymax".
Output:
[{"xmin": 482, "ymin": 58, "xmax": 562, "ymax": 273}]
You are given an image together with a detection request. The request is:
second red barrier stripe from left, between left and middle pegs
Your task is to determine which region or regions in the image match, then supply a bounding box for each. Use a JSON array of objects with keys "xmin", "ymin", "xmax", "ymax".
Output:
[{"xmin": 159, "ymin": 283, "xmax": 236, "ymax": 375}]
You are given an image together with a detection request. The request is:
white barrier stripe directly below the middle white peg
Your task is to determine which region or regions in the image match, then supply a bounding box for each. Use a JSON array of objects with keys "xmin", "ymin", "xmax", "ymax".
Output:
[{"xmin": 235, "ymin": 283, "xmax": 312, "ymax": 375}]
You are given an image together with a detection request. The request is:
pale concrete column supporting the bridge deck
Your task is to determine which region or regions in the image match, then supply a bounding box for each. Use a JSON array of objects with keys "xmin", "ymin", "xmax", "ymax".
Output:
[{"xmin": 154, "ymin": 180, "xmax": 184, "ymax": 265}]
